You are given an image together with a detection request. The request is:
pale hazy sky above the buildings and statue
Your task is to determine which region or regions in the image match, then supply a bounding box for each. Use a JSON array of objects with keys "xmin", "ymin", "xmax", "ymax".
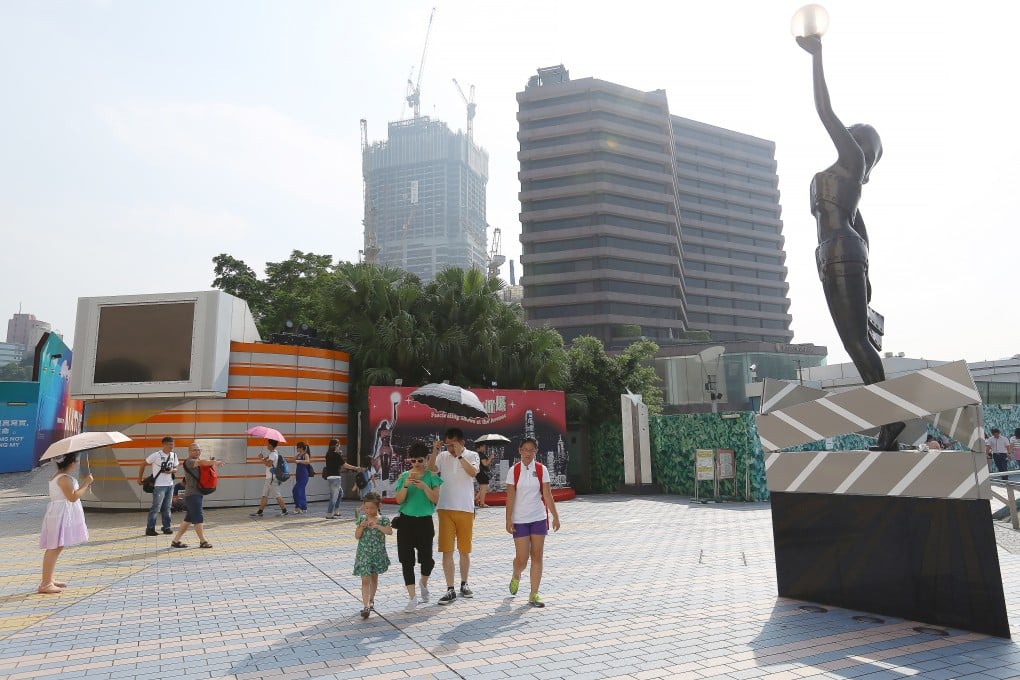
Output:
[{"xmin": 0, "ymin": 0, "xmax": 1020, "ymax": 363}]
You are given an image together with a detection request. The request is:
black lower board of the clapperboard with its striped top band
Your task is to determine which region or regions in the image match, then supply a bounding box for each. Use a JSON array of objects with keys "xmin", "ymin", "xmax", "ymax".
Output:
[{"xmin": 765, "ymin": 451, "xmax": 1010, "ymax": 638}]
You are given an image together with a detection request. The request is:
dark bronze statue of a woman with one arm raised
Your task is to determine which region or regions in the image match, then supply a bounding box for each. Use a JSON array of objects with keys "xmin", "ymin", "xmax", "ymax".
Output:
[{"xmin": 797, "ymin": 36, "xmax": 904, "ymax": 451}]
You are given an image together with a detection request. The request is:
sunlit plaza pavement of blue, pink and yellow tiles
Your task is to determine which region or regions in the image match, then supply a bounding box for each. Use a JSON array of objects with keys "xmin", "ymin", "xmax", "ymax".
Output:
[{"xmin": 0, "ymin": 474, "xmax": 1020, "ymax": 680}]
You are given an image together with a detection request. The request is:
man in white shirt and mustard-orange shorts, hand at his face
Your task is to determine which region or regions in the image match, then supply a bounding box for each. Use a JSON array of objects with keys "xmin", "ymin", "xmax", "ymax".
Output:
[{"xmin": 428, "ymin": 427, "xmax": 478, "ymax": 605}]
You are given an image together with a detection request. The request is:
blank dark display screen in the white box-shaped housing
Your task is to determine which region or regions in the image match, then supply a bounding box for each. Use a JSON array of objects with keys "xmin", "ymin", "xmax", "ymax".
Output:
[{"xmin": 93, "ymin": 302, "xmax": 195, "ymax": 383}]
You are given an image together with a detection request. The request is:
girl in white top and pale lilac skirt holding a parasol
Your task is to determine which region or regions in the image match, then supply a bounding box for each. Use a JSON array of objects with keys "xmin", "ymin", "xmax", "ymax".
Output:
[{"xmin": 37, "ymin": 453, "xmax": 92, "ymax": 595}]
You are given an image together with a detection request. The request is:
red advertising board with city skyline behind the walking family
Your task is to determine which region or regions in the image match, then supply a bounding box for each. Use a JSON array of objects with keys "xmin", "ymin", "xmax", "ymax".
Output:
[{"xmin": 361, "ymin": 386, "xmax": 568, "ymax": 496}]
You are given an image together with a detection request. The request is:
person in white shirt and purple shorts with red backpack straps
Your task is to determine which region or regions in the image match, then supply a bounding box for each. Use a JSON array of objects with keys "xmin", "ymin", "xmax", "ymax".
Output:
[{"xmin": 506, "ymin": 436, "xmax": 560, "ymax": 608}]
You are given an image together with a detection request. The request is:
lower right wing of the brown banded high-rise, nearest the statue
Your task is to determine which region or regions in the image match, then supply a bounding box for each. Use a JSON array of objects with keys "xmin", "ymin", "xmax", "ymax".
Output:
[{"xmin": 671, "ymin": 116, "xmax": 794, "ymax": 343}]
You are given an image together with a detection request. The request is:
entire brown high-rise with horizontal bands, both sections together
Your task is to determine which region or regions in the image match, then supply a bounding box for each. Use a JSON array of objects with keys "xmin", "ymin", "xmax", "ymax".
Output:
[{"xmin": 517, "ymin": 66, "xmax": 793, "ymax": 347}]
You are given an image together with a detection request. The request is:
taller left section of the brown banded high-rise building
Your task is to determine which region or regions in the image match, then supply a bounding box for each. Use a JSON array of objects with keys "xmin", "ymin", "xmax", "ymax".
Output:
[{"xmin": 517, "ymin": 65, "xmax": 686, "ymax": 346}]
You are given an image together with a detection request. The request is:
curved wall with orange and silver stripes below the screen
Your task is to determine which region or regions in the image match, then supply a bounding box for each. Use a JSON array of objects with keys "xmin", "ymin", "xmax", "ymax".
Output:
[{"xmin": 84, "ymin": 343, "xmax": 350, "ymax": 510}]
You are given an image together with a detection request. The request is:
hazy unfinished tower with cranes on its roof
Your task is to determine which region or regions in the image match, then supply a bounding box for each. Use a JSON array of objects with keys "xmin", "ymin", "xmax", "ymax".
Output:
[{"xmin": 363, "ymin": 116, "xmax": 489, "ymax": 280}]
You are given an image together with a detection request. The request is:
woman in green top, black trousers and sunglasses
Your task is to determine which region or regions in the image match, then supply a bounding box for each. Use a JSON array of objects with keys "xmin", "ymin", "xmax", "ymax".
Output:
[{"xmin": 395, "ymin": 440, "xmax": 443, "ymax": 612}]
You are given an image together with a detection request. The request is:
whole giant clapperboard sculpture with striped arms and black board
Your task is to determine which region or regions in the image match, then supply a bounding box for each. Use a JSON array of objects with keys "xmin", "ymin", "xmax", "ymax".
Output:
[{"xmin": 756, "ymin": 361, "xmax": 1010, "ymax": 637}]
